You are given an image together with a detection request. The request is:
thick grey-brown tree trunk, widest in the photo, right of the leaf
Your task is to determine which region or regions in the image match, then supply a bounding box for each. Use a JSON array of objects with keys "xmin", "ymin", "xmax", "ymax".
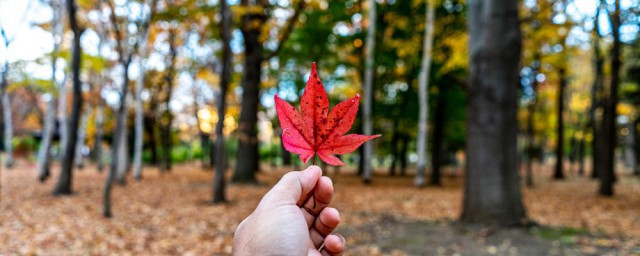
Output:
[{"xmin": 461, "ymin": 0, "xmax": 525, "ymax": 226}]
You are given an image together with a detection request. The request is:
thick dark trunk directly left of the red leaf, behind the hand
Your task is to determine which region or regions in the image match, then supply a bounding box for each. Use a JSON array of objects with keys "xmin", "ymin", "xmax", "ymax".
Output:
[{"xmin": 233, "ymin": 10, "xmax": 265, "ymax": 183}]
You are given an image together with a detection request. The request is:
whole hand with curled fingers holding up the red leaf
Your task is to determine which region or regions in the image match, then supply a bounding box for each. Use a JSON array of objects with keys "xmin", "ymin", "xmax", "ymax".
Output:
[{"xmin": 233, "ymin": 166, "xmax": 346, "ymax": 256}]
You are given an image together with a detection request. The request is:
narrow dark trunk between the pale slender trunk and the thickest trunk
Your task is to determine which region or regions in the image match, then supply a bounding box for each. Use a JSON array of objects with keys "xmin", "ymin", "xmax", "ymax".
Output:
[{"xmin": 429, "ymin": 84, "xmax": 446, "ymax": 186}]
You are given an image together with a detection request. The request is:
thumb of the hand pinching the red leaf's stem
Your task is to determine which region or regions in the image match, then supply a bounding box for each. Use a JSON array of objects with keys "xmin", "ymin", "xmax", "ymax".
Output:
[{"xmin": 265, "ymin": 165, "xmax": 322, "ymax": 206}]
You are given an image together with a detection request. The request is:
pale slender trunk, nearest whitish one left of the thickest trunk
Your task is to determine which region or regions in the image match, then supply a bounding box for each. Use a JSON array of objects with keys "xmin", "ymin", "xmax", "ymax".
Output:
[{"xmin": 414, "ymin": 0, "xmax": 435, "ymax": 187}]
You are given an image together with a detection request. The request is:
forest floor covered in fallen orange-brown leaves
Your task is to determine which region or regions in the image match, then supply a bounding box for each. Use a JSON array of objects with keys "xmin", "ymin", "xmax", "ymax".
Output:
[{"xmin": 0, "ymin": 162, "xmax": 640, "ymax": 255}]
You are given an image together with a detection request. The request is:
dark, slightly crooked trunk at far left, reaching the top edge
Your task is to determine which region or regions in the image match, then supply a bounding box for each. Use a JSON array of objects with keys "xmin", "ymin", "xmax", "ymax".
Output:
[{"xmin": 53, "ymin": 0, "xmax": 84, "ymax": 195}]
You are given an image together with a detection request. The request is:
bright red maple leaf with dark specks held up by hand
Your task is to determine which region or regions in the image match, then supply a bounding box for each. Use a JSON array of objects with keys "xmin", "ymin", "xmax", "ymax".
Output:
[{"xmin": 274, "ymin": 62, "xmax": 380, "ymax": 166}]
